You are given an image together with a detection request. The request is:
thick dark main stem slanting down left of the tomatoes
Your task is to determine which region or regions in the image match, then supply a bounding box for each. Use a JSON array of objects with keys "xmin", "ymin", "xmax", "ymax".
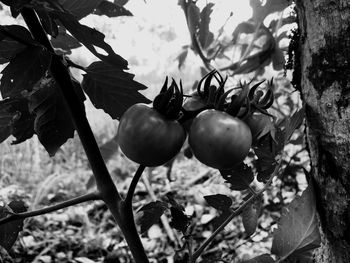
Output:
[{"xmin": 21, "ymin": 8, "xmax": 149, "ymax": 263}]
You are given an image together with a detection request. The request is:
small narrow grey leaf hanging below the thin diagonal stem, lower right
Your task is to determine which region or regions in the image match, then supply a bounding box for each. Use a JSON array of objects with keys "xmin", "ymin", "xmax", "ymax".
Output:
[{"xmin": 242, "ymin": 195, "xmax": 262, "ymax": 236}]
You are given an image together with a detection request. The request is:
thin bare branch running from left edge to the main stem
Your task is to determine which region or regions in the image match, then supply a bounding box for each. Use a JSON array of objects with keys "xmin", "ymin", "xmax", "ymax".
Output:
[{"xmin": 0, "ymin": 192, "xmax": 101, "ymax": 225}]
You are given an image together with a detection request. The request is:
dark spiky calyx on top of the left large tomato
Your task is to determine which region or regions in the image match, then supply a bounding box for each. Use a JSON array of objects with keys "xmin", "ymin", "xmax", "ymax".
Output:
[{"xmin": 153, "ymin": 77, "xmax": 183, "ymax": 120}]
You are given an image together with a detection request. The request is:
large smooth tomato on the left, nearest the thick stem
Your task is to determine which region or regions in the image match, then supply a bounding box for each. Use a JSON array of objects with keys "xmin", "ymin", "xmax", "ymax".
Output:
[{"xmin": 118, "ymin": 103, "xmax": 186, "ymax": 166}]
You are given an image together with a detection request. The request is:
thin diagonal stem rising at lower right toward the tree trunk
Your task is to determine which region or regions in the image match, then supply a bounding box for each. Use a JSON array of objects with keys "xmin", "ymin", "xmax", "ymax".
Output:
[{"xmin": 192, "ymin": 162, "xmax": 282, "ymax": 263}]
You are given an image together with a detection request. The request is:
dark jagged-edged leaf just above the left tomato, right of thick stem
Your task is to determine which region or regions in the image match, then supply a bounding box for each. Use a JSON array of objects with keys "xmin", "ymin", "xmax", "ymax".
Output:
[{"xmin": 82, "ymin": 62, "xmax": 150, "ymax": 119}]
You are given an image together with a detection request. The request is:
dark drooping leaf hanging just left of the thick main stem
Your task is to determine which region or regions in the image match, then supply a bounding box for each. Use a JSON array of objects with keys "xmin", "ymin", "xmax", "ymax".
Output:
[{"xmin": 29, "ymin": 78, "xmax": 75, "ymax": 156}]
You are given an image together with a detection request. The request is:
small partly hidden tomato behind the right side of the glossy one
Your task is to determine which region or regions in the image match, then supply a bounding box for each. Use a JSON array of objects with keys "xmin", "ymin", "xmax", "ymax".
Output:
[{"xmin": 244, "ymin": 112, "xmax": 273, "ymax": 142}]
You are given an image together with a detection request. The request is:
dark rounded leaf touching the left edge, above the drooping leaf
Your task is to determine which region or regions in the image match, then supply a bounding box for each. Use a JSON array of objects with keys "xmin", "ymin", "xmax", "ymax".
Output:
[{"xmin": 0, "ymin": 47, "xmax": 51, "ymax": 98}]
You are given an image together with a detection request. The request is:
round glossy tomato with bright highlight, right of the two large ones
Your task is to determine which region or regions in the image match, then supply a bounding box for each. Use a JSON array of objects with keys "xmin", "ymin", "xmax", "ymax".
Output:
[{"xmin": 188, "ymin": 110, "xmax": 252, "ymax": 169}]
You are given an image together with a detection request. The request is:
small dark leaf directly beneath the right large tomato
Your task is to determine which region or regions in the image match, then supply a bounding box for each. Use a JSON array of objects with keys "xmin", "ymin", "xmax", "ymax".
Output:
[{"xmin": 220, "ymin": 162, "xmax": 254, "ymax": 191}]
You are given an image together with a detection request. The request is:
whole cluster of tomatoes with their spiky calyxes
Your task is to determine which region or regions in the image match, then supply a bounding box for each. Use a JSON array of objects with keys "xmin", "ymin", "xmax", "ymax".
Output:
[{"xmin": 118, "ymin": 71, "xmax": 273, "ymax": 170}]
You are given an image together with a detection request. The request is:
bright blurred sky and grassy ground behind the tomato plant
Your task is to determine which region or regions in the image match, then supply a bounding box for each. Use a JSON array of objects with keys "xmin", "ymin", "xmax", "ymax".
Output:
[{"xmin": 0, "ymin": 0, "xmax": 308, "ymax": 263}]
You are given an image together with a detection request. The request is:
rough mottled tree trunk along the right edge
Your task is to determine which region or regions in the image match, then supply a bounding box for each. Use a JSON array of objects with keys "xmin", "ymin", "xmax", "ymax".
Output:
[{"xmin": 296, "ymin": 0, "xmax": 350, "ymax": 263}]
